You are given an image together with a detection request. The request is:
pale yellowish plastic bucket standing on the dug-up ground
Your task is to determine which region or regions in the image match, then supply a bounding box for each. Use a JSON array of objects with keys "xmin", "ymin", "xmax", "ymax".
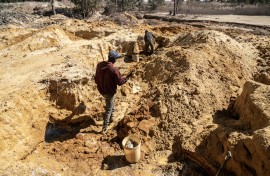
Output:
[{"xmin": 122, "ymin": 135, "xmax": 141, "ymax": 163}]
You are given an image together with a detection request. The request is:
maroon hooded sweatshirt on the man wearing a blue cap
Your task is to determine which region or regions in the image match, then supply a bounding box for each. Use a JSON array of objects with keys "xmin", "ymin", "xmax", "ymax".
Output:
[{"xmin": 95, "ymin": 61, "xmax": 127, "ymax": 95}]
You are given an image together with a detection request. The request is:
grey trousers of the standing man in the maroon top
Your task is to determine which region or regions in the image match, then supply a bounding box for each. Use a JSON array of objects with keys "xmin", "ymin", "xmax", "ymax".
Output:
[{"xmin": 102, "ymin": 94, "xmax": 115, "ymax": 128}]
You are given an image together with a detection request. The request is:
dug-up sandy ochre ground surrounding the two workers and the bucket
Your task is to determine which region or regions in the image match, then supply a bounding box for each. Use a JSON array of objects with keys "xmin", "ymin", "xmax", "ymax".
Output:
[{"xmin": 0, "ymin": 3, "xmax": 270, "ymax": 176}]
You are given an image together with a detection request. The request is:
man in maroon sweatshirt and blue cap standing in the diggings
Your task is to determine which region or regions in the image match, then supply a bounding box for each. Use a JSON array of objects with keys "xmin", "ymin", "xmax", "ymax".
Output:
[{"xmin": 95, "ymin": 50, "xmax": 133, "ymax": 134}]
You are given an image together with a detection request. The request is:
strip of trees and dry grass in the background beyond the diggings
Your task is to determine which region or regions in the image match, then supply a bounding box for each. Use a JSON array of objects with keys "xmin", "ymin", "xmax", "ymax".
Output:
[{"xmin": 0, "ymin": 0, "xmax": 270, "ymax": 17}]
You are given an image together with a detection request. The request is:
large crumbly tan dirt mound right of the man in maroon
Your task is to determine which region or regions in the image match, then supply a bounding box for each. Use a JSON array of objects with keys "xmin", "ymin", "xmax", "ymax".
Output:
[{"xmin": 141, "ymin": 31, "xmax": 256, "ymax": 148}]
